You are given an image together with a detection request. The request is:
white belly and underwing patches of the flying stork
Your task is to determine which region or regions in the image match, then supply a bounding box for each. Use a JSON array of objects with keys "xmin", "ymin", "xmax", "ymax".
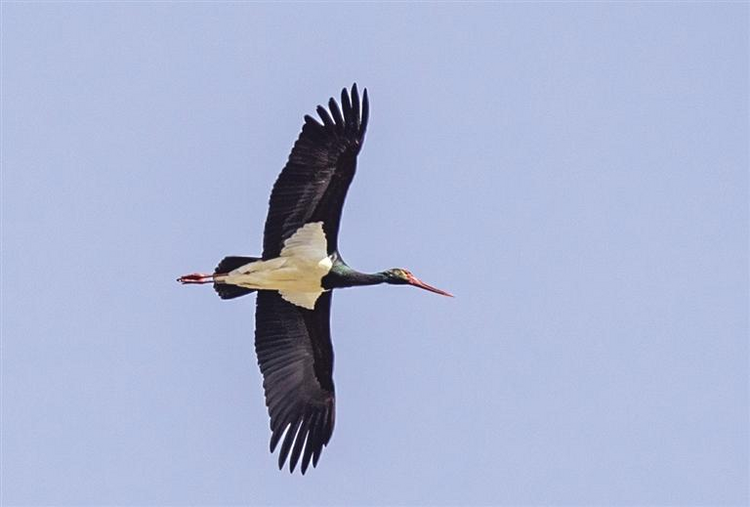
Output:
[{"xmin": 217, "ymin": 222, "xmax": 333, "ymax": 310}]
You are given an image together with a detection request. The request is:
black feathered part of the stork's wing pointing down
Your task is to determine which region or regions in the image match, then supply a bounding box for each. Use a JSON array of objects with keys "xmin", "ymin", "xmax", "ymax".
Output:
[{"xmin": 255, "ymin": 290, "xmax": 335, "ymax": 474}]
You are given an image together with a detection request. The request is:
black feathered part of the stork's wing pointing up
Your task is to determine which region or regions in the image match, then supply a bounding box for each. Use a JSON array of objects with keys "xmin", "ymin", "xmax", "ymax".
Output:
[{"xmin": 263, "ymin": 84, "xmax": 369, "ymax": 259}]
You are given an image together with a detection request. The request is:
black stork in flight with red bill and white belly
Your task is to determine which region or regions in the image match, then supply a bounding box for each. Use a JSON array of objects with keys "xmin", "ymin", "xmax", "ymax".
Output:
[{"xmin": 177, "ymin": 84, "xmax": 451, "ymax": 474}]
